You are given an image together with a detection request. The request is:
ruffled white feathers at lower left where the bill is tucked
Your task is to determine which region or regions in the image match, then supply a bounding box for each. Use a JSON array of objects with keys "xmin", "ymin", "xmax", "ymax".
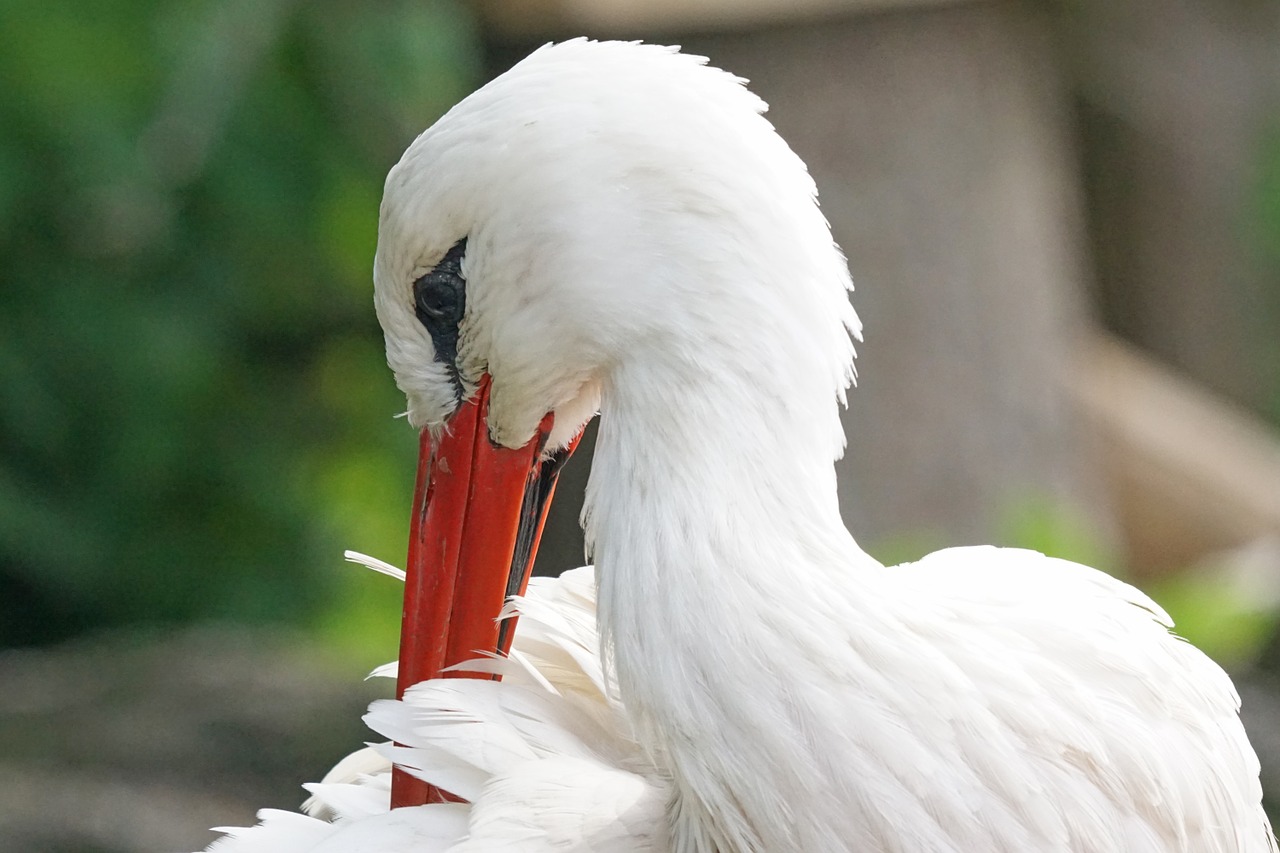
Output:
[{"xmin": 199, "ymin": 560, "xmax": 669, "ymax": 853}]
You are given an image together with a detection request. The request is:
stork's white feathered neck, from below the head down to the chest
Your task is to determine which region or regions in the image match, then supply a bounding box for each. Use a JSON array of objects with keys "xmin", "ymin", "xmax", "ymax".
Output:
[{"xmin": 584, "ymin": 318, "xmax": 878, "ymax": 850}]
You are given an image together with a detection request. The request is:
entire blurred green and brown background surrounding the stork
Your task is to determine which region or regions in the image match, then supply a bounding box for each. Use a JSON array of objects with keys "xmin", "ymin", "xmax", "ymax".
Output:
[{"xmin": 0, "ymin": 0, "xmax": 1280, "ymax": 853}]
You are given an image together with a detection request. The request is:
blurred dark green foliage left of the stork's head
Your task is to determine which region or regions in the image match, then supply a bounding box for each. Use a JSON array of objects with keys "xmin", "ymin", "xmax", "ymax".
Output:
[{"xmin": 0, "ymin": 0, "xmax": 480, "ymax": 657}]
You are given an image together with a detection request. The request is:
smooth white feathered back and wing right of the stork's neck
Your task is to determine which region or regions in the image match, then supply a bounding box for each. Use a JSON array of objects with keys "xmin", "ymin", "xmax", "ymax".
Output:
[{"xmin": 891, "ymin": 547, "xmax": 1275, "ymax": 853}]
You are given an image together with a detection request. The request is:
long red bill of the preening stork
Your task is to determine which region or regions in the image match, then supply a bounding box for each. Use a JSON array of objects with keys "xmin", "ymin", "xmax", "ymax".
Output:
[{"xmin": 392, "ymin": 375, "xmax": 576, "ymax": 808}]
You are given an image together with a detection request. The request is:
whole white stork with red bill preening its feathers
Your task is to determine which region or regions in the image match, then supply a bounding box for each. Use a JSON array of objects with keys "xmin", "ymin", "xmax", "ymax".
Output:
[{"xmin": 204, "ymin": 40, "xmax": 1276, "ymax": 853}]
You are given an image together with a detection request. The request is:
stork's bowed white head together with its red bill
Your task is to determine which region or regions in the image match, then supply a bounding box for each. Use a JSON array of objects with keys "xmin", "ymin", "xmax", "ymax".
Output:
[{"xmin": 374, "ymin": 40, "xmax": 858, "ymax": 802}]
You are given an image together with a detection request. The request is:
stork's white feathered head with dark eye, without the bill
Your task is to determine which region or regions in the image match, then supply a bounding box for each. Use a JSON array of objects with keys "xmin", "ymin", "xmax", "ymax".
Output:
[{"xmin": 374, "ymin": 40, "xmax": 856, "ymax": 450}]
